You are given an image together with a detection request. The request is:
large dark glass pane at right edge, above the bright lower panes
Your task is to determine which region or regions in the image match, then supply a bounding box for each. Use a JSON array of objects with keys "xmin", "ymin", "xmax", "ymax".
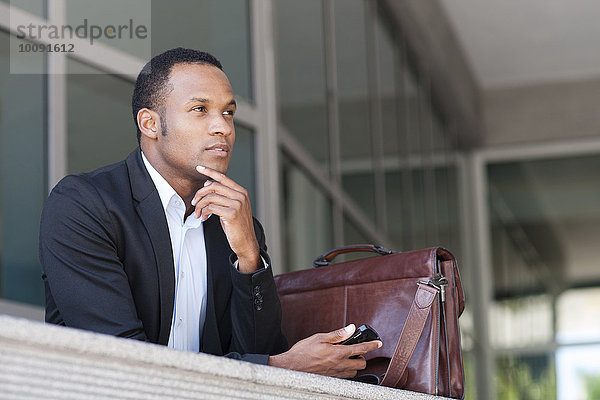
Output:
[{"xmin": 488, "ymin": 155, "xmax": 600, "ymax": 293}]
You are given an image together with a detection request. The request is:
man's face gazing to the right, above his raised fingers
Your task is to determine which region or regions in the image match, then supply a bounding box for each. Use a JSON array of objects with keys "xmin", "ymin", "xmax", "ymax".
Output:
[{"xmin": 155, "ymin": 64, "xmax": 236, "ymax": 181}]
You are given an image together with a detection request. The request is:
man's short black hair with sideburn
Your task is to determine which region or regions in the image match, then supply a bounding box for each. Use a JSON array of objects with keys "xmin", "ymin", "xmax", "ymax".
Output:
[{"xmin": 131, "ymin": 47, "xmax": 223, "ymax": 144}]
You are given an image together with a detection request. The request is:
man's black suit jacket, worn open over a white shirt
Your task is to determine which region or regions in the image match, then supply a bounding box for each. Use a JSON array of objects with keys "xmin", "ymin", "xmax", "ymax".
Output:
[{"xmin": 40, "ymin": 148, "xmax": 287, "ymax": 363}]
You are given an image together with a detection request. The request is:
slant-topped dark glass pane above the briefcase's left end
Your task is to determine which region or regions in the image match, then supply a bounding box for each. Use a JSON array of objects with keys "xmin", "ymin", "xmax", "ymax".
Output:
[{"xmin": 281, "ymin": 154, "xmax": 333, "ymax": 271}]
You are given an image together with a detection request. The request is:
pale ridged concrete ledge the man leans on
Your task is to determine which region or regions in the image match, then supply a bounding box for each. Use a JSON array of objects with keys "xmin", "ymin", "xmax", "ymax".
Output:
[{"xmin": 0, "ymin": 315, "xmax": 450, "ymax": 400}]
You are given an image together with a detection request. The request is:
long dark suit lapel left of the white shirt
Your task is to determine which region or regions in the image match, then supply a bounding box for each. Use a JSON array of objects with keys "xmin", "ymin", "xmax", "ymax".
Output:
[{"xmin": 126, "ymin": 148, "xmax": 175, "ymax": 345}]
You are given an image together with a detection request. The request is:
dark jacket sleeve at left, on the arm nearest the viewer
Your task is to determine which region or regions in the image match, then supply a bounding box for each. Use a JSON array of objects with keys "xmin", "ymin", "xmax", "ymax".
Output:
[{"xmin": 39, "ymin": 176, "xmax": 147, "ymax": 340}]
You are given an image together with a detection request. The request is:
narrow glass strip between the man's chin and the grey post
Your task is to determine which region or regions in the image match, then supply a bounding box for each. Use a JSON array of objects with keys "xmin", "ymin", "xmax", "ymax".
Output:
[{"xmin": 227, "ymin": 123, "xmax": 257, "ymax": 213}]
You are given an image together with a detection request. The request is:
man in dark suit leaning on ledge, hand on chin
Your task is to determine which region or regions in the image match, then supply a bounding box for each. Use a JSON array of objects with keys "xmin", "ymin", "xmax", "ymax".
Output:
[{"xmin": 40, "ymin": 48, "xmax": 381, "ymax": 377}]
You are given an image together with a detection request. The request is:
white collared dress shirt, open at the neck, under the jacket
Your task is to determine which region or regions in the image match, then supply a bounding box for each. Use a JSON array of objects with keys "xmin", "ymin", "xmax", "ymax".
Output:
[{"xmin": 142, "ymin": 153, "xmax": 207, "ymax": 352}]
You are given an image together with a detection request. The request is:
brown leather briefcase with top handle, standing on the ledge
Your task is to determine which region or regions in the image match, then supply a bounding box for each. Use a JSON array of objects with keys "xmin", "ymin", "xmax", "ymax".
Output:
[{"xmin": 275, "ymin": 245, "xmax": 464, "ymax": 398}]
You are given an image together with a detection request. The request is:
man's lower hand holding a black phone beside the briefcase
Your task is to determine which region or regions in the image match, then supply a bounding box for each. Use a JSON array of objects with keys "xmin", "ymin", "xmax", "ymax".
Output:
[{"xmin": 268, "ymin": 324, "xmax": 383, "ymax": 378}]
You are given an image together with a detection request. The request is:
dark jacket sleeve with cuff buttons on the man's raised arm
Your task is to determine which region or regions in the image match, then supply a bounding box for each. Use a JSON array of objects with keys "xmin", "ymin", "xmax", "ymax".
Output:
[{"xmin": 228, "ymin": 220, "xmax": 288, "ymax": 364}]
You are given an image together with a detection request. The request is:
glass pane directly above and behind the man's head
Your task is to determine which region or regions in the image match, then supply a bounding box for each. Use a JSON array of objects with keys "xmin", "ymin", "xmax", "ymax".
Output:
[{"xmin": 152, "ymin": 0, "xmax": 254, "ymax": 101}]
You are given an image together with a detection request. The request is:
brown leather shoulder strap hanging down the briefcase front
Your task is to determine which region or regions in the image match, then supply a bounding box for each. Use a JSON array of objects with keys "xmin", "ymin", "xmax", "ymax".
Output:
[{"xmin": 381, "ymin": 284, "xmax": 439, "ymax": 387}]
